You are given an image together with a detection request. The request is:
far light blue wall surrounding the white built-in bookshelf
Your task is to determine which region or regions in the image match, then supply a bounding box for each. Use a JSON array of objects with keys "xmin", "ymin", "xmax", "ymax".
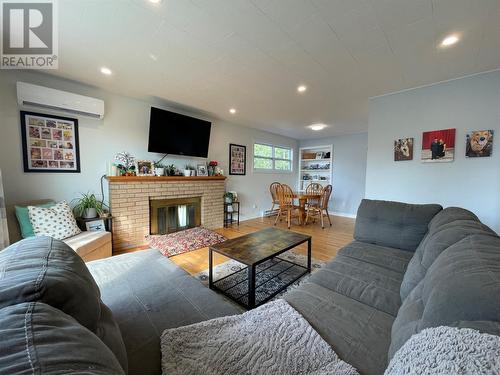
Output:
[{"xmin": 300, "ymin": 133, "xmax": 368, "ymax": 216}]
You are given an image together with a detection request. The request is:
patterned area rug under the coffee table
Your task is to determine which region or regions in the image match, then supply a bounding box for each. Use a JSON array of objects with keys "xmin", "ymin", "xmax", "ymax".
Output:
[{"xmin": 194, "ymin": 251, "xmax": 326, "ymax": 300}]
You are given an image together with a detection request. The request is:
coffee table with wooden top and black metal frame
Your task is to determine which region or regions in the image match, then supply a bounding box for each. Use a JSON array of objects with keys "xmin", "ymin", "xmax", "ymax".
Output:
[{"xmin": 208, "ymin": 228, "xmax": 311, "ymax": 309}]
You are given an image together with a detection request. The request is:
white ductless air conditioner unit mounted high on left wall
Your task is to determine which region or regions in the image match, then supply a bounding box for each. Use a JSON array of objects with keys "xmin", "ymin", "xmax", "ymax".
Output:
[{"xmin": 17, "ymin": 82, "xmax": 104, "ymax": 119}]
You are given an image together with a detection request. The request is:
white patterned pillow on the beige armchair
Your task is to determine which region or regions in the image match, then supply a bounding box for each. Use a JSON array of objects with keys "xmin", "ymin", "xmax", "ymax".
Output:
[{"xmin": 28, "ymin": 201, "xmax": 81, "ymax": 240}]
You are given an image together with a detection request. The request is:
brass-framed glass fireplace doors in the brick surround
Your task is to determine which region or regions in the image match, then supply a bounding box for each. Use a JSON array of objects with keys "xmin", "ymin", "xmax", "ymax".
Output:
[{"xmin": 150, "ymin": 197, "xmax": 201, "ymax": 234}]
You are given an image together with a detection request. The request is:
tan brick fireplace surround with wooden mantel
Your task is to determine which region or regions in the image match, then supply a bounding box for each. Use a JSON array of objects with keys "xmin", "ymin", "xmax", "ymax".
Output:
[{"xmin": 107, "ymin": 176, "xmax": 226, "ymax": 252}]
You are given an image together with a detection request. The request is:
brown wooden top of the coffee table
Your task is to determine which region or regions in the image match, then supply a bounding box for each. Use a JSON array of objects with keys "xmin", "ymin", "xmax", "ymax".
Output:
[{"xmin": 210, "ymin": 228, "xmax": 311, "ymax": 266}]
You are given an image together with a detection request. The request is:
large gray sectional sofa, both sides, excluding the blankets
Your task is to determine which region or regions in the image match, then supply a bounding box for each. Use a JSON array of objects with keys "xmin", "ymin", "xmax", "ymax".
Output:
[{"xmin": 0, "ymin": 200, "xmax": 500, "ymax": 374}]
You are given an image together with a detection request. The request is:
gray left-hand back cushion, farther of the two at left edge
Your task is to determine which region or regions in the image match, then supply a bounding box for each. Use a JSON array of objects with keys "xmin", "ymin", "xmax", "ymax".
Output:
[{"xmin": 0, "ymin": 237, "xmax": 127, "ymax": 369}]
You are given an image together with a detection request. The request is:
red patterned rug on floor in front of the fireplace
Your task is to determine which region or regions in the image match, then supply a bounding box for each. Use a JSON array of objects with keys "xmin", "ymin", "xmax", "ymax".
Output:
[{"xmin": 146, "ymin": 227, "xmax": 227, "ymax": 257}]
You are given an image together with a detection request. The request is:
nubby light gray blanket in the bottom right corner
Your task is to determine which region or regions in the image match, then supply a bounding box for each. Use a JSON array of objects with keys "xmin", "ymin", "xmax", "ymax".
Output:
[{"xmin": 385, "ymin": 326, "xmax": 500, "ymax": 375}]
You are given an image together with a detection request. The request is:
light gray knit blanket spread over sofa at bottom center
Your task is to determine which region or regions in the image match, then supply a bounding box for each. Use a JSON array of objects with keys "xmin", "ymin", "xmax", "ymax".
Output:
[{"xmin": 161, "ymin": 299, "xmax": 358, "ymax": 375}]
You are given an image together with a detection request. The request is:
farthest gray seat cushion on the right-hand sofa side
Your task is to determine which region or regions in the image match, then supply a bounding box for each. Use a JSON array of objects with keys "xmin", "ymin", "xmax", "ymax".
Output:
[{"xmin": 337, "ymin": 241, "xmax": 413, "ymax": 274}]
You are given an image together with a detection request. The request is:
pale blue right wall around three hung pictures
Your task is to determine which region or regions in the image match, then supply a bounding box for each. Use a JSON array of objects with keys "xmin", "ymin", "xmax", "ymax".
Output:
[{"xmin": 366, "ymin": 71, "xmax": 500, "ymax": 232}]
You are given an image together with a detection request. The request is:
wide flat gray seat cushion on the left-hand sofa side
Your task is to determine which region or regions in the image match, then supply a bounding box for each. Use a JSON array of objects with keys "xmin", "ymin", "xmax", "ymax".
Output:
[{"xmin": 87, "ymin": 250, "xmax": 242, "ymax": 375}]
